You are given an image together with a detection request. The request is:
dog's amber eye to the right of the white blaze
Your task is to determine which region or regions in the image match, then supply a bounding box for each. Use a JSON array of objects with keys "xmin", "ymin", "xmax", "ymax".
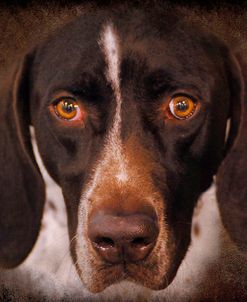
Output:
[{"xmin": 169, "ymin": 96, "xmax": 197, "ymax": 120}]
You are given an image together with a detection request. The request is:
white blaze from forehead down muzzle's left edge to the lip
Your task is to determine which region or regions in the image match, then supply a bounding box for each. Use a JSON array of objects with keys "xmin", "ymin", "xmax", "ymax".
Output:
[{"xmin": 76, "ymin": 25, "xmax": 129, "ymax": 282}]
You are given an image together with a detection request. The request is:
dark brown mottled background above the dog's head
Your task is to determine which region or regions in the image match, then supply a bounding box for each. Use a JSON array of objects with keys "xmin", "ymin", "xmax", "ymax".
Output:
[{"xmin": 0, "ymin": 0, "xmax": 247, "ymax": 72}]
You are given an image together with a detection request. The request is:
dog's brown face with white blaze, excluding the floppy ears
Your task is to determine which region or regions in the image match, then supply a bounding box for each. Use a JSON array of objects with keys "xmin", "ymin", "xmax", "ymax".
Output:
[{"xmin": 31, "ymin": 10, "xmax": 229, "ymax": 291}]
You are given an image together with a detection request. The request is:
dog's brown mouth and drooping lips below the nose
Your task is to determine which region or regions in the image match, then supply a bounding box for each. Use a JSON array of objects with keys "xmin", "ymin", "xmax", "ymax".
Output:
[{"xmin": 74, "ymin": 229, "xmax": 180, "ymax": 293}]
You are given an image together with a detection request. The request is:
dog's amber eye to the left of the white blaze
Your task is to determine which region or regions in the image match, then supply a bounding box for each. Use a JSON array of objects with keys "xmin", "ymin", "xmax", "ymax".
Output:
[{"xmin": 54, "ymin": 98, "xmax": 80, "ymax": 120}]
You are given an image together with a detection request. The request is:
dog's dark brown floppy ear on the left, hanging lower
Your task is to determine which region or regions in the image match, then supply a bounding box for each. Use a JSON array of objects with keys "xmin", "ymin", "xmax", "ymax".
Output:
[{"xmin": 0, "ymin": 54, "xmax": 45, "ymax": 268}]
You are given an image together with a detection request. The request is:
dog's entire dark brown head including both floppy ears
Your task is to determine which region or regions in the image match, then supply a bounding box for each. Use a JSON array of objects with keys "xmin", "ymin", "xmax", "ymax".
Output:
[{"xmin": 0, "ymin": 11, "xmax": 247, "ymax": 292}]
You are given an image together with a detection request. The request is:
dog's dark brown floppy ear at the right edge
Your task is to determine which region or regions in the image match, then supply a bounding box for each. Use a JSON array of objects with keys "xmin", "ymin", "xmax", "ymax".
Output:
[{"xmin": 216, "ymin": 51, "xmax": 247, "ymax": 250}]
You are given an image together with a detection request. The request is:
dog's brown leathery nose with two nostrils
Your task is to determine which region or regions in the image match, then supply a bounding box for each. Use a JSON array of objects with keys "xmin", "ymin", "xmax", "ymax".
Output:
[{"xmin": 88, "ymin": 214, "xmax": 159, "ymax": 263}]
